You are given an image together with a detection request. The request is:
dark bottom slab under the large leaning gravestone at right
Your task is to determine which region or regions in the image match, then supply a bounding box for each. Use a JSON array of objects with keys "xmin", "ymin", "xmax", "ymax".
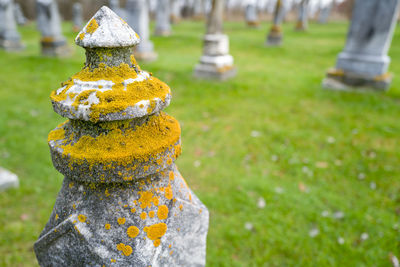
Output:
[{"xmin": 322, "ymin": 69, "xmax": 392, "ymax": 91}]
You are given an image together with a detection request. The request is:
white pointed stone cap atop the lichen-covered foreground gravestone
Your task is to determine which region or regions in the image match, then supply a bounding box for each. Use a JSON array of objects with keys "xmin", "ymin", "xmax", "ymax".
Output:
[{"xmin": 75, "ymin": 6, "xmax": 140, "ymax": 48}]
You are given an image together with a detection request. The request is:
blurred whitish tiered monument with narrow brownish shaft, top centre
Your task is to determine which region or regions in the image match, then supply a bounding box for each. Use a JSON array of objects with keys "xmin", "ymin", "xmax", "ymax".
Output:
[{"xmin": 194, "ymin": 0, "xmax": 237, "ymax": 80}]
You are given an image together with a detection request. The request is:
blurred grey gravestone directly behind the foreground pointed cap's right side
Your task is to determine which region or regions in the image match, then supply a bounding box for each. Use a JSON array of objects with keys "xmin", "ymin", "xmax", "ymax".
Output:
[{"xmin": 126, "ymin": 0, "xmax": 157, "ymax": 62}]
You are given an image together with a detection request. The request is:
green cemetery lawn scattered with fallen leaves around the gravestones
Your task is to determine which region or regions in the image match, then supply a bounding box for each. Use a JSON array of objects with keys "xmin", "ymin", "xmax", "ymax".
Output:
[{"xmin": 0, "ymin": 19, "xmax": 400, "ymax": 266}]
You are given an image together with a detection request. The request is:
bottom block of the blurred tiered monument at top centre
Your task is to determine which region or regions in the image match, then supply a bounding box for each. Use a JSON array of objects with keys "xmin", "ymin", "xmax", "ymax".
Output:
[{"xmin": 194, "ymin": 63, "xmax": 237, "ymax": 81}]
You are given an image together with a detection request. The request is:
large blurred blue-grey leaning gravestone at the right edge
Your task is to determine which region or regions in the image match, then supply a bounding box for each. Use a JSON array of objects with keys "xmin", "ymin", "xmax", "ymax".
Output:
[{"xmin": 323, "ymin": 0, "xmax": 400, "ymax": 90}]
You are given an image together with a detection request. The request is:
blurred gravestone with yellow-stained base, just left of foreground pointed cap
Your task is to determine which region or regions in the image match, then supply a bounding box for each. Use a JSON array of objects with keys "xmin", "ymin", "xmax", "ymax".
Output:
[{"xmin": 36, "ymin": 0, "xmax": 71, "ymax": 57}]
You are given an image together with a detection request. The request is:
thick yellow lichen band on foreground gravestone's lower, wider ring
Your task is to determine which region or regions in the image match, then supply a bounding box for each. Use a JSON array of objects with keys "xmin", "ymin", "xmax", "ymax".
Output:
[{"xmin": 51, "ymin": 113, "xmax": 180, "ymax": 168}]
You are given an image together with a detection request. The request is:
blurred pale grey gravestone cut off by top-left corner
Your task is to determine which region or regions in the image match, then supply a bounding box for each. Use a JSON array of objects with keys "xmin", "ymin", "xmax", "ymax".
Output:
[{"xmin": 0, "ymin": 0, "xmax": 23, "ymax": 51}]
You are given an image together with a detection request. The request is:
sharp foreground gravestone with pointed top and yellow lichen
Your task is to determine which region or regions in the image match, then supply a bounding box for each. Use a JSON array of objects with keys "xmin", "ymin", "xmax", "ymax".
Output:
[{"xmin": 34, "ymin": 7, "xmax": 209, "ymax": 266}]
